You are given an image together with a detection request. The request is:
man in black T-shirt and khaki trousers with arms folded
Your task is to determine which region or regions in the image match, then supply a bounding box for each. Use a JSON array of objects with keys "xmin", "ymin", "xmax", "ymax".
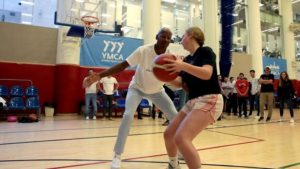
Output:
[{"xmin": 258, "ymin": 67, "xmax": 274, "ymax": 121}]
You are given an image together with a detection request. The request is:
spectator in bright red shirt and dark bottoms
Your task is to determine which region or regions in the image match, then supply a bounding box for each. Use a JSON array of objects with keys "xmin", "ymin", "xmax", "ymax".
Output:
[{"xmin": 235, "ymin": 73, "xmax": 249, "ymax": 118}]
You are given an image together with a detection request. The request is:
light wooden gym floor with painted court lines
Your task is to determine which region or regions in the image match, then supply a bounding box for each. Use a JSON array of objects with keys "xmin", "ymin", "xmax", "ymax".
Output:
[{"xmin": 0, "ymin": 109, "xmax": 300, "ymax": 169}]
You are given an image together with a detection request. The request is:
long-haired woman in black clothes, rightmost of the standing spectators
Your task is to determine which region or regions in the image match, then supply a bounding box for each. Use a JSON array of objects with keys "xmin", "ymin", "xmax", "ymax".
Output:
[{"xmin": 277, "ymin": 71, "xmax": 295, "ymax": 123}]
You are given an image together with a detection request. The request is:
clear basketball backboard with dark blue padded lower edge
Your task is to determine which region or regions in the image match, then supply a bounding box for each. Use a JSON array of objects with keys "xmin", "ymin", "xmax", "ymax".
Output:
[{"xmin": 55, "ymin": 0, "xmax": 118, "ymax": 37}]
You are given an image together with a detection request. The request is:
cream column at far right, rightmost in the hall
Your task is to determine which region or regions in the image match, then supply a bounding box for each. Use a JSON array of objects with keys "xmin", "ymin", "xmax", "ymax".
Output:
[{"xmin": 280, "ymin": 0, "xmax": 296, "ymax": 79}]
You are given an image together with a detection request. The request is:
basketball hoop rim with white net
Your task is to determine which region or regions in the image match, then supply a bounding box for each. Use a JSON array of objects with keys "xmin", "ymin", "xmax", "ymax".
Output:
[{"xmin": 81, "ymin": 16, "xmax": 99, "ymax": 39}]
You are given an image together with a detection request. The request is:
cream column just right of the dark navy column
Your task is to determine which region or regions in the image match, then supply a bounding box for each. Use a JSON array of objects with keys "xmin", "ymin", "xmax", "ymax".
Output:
[{"xmin": 247, "ymin": 0, "xmax": 263, "ymax": 75}]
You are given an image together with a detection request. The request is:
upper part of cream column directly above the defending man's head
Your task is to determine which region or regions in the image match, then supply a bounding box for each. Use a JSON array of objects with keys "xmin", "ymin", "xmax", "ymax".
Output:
[{"xmin": 142, "ymin": 0, "xmax": 161, "ymax": 44}]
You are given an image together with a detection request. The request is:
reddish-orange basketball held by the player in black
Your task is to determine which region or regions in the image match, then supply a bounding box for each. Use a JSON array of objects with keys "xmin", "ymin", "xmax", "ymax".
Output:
[{"xmin": 152, "ymin": 53, "xmax": 178, "ymax": 82}]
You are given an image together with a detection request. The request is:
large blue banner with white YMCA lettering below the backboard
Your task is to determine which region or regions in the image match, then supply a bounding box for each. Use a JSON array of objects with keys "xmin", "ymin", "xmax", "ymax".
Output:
[{"xmin": 80, "ymin": 35, "xmax": 143, "ymax": 67}]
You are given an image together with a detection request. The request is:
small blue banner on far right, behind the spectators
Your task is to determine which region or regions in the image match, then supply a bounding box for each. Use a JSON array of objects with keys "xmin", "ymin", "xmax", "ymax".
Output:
[{"xmin": 263, "ymin": 57, "xmax": 287, "ymax": 79}]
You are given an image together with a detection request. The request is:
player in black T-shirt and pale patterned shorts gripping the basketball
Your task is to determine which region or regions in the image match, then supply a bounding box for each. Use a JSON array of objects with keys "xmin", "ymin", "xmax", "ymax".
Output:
[{"xmin": 164, "ymin": 27, "xmax": 223, "ymax": 169}]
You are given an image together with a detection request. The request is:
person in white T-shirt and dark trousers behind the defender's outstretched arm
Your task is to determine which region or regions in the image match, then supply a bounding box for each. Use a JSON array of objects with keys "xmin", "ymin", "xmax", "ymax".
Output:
[{"xmin": 100, "ymin": 76, "xmax": 119, "ymax": 120}]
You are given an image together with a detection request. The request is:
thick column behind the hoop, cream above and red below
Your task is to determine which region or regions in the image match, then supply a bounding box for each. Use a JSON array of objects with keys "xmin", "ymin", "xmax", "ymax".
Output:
[{"xmin": 54, "ymin": 1, "xmax": 82, "ymax": 113}]
